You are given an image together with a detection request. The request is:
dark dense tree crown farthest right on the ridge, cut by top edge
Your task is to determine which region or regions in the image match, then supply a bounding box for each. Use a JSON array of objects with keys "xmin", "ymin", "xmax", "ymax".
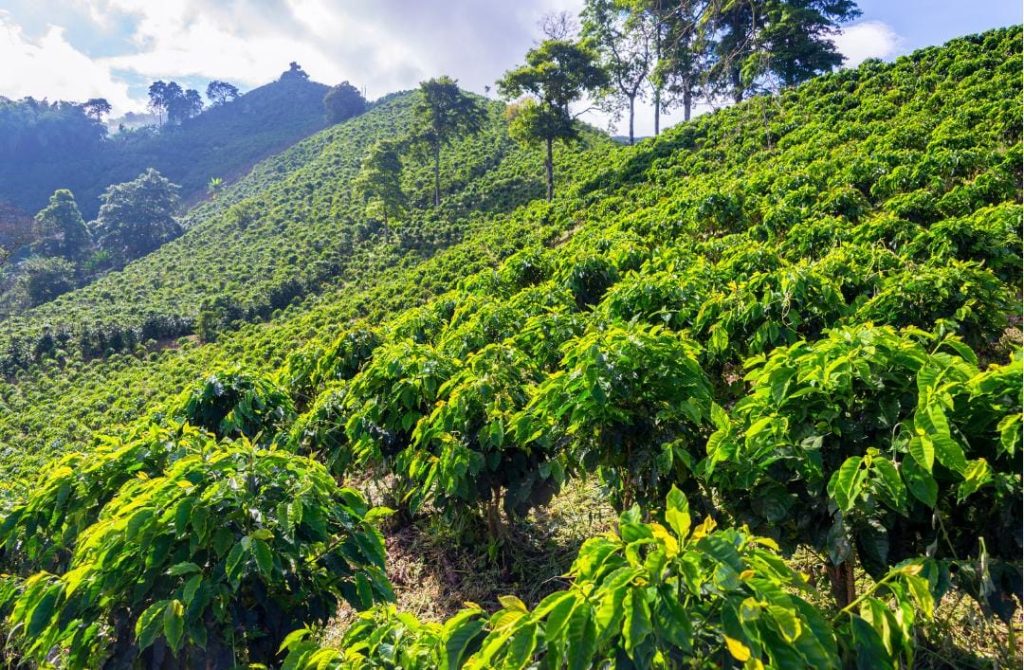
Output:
[{"xmin": 712, "ymin": 0, "xmax": 860, "ymax": 102}]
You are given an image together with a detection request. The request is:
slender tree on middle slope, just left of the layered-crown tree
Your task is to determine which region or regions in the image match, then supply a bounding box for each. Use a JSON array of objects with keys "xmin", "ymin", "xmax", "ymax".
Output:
[{"xmin": 413, "ymin": 76, "xmax": 486, "ymax": 207}]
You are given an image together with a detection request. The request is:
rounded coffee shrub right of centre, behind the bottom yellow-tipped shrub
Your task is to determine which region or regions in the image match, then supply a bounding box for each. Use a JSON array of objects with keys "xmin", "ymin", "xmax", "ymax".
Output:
[{"xmin": 522, "ymin": 325, "xmax": 711, "ymax": 506}]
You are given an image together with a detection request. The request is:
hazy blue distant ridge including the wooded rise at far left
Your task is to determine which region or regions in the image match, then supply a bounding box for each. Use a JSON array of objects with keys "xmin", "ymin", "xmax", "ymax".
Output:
[{"xmin": 0, "ymin": 72, "xmax": 328, "ymax": 219}]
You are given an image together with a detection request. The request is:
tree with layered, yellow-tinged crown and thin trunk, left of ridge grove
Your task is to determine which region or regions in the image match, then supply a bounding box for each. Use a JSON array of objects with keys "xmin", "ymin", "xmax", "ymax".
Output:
[{"xmin": 498, "ymin": 40, "xmax": 608, "ymax": 201}]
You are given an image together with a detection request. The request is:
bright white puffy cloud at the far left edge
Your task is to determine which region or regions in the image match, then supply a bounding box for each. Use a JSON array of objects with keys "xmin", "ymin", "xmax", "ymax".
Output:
[{"xmin": 0, "ymin": 11, "xmax": 139, "ymax": 114}]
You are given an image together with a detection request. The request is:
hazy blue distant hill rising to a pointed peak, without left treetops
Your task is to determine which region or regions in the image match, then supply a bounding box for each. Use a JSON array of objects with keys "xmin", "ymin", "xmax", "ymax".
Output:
[{"xmin": 0, "ymin": 73, "xmax": 328, "ymax": 220}]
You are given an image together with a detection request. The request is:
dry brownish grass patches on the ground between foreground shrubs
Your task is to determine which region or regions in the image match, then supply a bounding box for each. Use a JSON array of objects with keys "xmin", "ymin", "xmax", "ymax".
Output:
[{"xmin": 325, "ymin": 480, "xmax": 1024, "ymax": 670}]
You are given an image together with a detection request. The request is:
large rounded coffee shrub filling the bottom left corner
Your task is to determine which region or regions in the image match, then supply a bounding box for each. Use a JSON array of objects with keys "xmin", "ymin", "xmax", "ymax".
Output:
[{"xmin": 2, "ymin": 443, "xmax": 392, "ymax": 668}]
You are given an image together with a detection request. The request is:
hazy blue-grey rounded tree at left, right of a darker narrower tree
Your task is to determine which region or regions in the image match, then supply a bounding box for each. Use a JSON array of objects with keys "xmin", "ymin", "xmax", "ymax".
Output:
[{"xmin": 91, "ymin": 168, "xmax": 181, "ymax": 262}]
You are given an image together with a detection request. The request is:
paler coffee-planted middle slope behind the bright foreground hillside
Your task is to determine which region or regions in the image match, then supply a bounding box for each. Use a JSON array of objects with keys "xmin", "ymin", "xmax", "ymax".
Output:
[{"xmin": 0, "ymin": 94, "xmax": 606, "ymax": 373}]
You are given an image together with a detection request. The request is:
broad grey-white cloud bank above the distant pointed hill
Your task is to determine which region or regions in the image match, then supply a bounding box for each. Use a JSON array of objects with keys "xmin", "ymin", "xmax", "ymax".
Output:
[{"xmin": 76, "ymin": 0, "xmax": 582, "ymax": 103}]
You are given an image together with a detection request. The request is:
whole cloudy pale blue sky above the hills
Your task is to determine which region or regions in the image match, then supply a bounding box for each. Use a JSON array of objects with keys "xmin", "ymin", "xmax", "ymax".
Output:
[{"xmin": 0, "ymin": 0, "xmax": 1022, "ymax": 135}]
